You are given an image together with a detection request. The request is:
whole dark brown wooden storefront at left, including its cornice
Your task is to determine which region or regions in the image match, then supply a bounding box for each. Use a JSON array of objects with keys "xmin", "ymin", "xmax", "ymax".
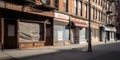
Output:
[{"xmin": 0, "ymin": 2, "xmax": 54, "ymax": 49}]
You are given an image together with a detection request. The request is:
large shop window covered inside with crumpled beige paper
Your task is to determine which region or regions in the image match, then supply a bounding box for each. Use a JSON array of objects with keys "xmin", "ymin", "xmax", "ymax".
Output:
[{"xmin": 19, "ymin": 22, "xmax": 44, "ymax": 41}]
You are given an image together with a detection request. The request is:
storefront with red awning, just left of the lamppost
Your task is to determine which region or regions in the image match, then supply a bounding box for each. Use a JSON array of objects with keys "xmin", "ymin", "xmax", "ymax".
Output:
[{"xmin": 71, "ymin": 17, "xmax": 88, "ymax": 44}]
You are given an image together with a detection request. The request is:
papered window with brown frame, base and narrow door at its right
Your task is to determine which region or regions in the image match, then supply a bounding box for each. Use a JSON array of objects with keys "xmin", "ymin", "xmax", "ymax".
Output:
[{"xmin": 18, "ymin": 17, "xmax": 53, "ymax": 48}]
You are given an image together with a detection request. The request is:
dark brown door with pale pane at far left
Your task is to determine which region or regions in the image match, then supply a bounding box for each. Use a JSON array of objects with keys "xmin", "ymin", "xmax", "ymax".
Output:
[{"xmin": 4, "ymin": 19, "xmax": 17, "ymax": 49}]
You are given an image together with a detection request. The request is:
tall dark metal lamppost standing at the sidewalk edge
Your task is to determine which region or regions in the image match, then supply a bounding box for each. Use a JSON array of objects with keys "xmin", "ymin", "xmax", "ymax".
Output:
[{"xmin": 88, "ymin": 0, "xmax": 92, "ymax": 52}]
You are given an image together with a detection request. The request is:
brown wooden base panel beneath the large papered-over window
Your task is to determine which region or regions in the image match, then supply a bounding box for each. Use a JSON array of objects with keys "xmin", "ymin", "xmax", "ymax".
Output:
[{"xmin": 19, "ymin": 41, "xmax": 45, "ymax": 48}]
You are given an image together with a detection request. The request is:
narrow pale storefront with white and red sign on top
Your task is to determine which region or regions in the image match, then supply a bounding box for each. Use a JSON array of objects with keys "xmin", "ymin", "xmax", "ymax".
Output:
[{"xmin": 54, "ymin": 12, "xmax": 70, "ymax": 45}]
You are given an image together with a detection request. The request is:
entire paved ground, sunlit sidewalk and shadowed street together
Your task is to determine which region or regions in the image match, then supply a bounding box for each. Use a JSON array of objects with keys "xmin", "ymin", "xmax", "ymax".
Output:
[{"xmin": 0, "ymin": 41, "xmax": 120, "ymax": 60}]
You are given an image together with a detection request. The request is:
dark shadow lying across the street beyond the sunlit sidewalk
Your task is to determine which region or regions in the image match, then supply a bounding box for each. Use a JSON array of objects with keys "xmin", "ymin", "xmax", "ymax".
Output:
[{"xmin": 1, "ymin": 43, "xmax": 120, "ymax": 60}]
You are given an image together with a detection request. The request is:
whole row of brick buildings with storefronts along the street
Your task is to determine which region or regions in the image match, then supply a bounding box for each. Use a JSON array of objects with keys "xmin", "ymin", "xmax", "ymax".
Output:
[{"xmin": 0, "ymin": 0, "xmax": 116, "ymax": 49}]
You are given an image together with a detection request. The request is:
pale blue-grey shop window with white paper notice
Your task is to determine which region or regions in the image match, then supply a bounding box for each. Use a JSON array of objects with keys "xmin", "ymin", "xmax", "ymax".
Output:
[{"xmin": 54, "ymin": 25, "xmax": 69, "ymax": 41}]
